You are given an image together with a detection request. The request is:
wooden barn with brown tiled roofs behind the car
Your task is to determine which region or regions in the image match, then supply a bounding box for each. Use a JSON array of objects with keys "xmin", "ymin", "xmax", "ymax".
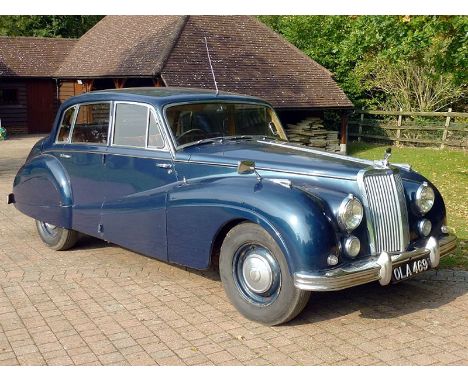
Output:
[{"xmin": 0, "ymin": 16, "xmax": 353, "ymax": 148}]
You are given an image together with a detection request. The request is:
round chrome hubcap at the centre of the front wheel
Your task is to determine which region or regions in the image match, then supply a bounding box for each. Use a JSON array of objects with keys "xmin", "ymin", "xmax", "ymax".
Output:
[{"xmin": 242, "ymin": 253, "xmax": 273, "ymax": 293}]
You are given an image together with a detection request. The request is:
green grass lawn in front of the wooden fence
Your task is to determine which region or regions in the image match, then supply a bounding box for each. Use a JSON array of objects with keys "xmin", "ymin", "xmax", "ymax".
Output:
[{"xmin": 348, "ymin": 142, "xmax": 468, "ymax": 270}]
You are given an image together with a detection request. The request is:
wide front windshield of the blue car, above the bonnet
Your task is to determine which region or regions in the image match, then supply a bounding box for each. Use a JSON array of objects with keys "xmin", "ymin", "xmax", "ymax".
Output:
[{"xmin": 166, "ymin": 102, "xmax": 286, "ymax": 146}]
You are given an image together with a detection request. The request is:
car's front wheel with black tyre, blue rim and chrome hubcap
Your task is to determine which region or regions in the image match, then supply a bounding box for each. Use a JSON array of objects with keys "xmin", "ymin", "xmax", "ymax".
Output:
[{"xmin": 219, "ymin": 223, "xmax": 310, "ymax": 325}]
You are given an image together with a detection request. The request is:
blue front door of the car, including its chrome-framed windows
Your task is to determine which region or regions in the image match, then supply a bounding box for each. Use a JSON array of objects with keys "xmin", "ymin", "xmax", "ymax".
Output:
[{"xmin": 102, "ymin": 102, "xmax": 177, "ymax": 260}]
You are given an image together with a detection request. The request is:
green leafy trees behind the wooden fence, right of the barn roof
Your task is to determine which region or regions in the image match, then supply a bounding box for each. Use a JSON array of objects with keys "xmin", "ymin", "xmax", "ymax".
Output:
[{"xmin": 260, "ymin": 16, "xmax": 468, "ymax": 108}]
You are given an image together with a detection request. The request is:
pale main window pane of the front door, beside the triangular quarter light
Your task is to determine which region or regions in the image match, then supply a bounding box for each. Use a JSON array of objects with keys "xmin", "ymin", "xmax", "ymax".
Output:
[{"xmin": 112, "ymin": 103, "xmax": 150, "ymax": 147}]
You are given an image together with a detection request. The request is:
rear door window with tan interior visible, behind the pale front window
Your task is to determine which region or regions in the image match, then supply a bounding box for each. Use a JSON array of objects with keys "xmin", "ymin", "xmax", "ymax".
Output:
[{"xmin": 71, "ymin": 103, "xmax": 110, "ymax": 145}]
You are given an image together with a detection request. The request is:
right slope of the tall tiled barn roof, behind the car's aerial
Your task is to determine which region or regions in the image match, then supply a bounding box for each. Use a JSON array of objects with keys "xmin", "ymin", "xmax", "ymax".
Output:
[{"xmin": 162, "ymin": 16, "xmax": 353, "ymax": 108}]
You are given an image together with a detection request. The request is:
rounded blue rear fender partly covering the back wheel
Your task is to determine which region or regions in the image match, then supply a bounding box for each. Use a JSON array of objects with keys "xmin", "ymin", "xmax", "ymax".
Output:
[{"xmin": 13, "ymin": 155, "xmax": 73, "ymax": 228}]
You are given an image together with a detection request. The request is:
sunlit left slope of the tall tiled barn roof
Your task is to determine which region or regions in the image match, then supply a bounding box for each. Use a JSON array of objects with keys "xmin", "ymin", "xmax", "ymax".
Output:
[{"xmin": 57, "ymin": 16, "xmax": 186, "ymax": 78}]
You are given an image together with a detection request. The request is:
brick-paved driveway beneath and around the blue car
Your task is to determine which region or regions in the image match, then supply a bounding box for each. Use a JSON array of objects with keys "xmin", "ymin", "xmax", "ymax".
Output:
[{"xmin": 0, "ymin": 137, "xmax": 468, "ymax": 365}]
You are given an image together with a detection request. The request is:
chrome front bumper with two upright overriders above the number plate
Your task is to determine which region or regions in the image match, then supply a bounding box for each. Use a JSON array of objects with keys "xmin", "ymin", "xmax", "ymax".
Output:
[{"xmin": 294, "ymin": 235, "xmax": 457, "ymax": 291}]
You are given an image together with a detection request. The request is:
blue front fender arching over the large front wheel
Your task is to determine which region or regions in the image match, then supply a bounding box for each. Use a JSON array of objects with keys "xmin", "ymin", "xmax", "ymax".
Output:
[{"xmin": 167, "ymin": 176, "xmax": 337, "ymax": 273}]
